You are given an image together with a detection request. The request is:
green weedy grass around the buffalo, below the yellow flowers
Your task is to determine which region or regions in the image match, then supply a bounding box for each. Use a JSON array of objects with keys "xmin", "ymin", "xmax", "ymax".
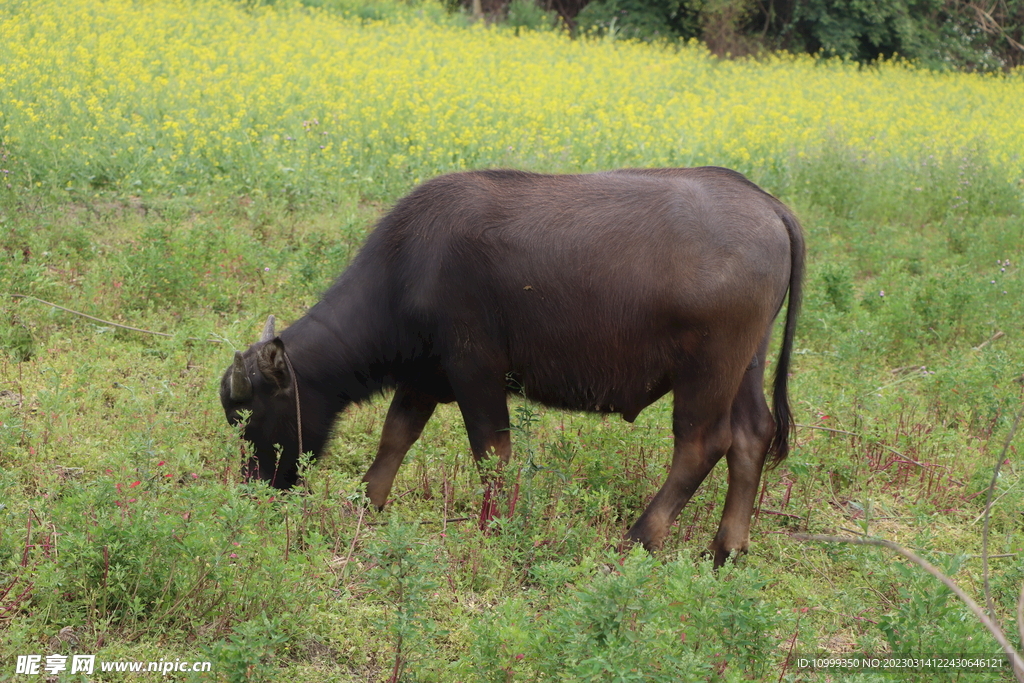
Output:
[{"xmin": 0, "ymin": 143, "xmax": 1024, "ymax": 681}]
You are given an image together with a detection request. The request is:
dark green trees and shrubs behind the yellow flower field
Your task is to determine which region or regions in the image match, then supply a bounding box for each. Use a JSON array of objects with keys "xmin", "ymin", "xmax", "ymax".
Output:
[{"xmin": 536, "ymin": 0, "xmax": 1024, "ymax": 71}]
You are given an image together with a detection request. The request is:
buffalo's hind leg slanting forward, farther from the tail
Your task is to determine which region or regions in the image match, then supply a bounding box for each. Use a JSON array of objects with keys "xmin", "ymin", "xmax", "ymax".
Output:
[{"xmin": 626, "ymin": 382, "xmax": 732, "ymax": 551}]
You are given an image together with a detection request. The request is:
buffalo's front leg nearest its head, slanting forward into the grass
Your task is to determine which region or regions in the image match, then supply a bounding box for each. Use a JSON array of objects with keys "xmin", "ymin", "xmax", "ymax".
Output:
[{"xmin": 362, "ymin": 385, "xmax": 437, "ymax": 509}]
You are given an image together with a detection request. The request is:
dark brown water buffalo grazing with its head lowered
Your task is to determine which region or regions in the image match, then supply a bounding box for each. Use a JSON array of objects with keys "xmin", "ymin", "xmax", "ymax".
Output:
[{"xmin": 220, "ymin": 167, "xmax": 804, "ymax": 564}]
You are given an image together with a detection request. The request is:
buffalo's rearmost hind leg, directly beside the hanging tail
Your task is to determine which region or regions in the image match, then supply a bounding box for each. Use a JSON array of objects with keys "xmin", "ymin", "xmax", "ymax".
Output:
[{"xmin": 708, "ymin": 356, "xmax": 775, "ymax": 566}]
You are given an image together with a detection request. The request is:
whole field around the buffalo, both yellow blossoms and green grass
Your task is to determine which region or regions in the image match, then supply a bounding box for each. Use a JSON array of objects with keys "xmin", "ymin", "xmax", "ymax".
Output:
[{"xmin": 0, "ymin": 0, "xmax": 1024, "ymax": 682}]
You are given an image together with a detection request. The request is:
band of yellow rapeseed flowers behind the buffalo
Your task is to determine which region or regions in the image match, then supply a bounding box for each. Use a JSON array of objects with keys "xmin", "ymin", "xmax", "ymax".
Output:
[{"xmin": 0, "ymin": 0, "xmax": 1024, "ymax": 198}]
